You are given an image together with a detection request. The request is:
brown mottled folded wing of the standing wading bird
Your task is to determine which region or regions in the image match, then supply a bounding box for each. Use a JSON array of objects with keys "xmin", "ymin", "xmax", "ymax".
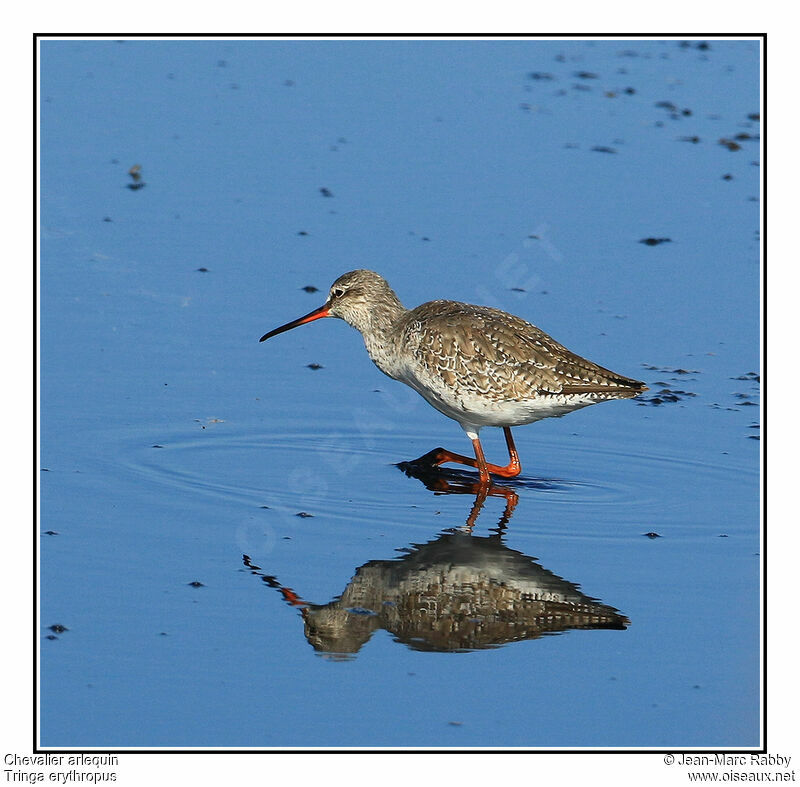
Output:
[{"xmin": 403, "ymin": 301, "xmax": 645, "ymax": 400}]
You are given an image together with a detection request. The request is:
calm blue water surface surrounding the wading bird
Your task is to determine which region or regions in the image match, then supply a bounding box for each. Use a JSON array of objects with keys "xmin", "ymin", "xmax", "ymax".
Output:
[{"xmin": 39, "ymin": 40, "xmax": 761, "ymax": 748}]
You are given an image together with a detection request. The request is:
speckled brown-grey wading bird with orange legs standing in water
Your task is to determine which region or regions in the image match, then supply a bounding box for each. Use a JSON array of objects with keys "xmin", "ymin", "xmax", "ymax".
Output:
[{"xmin": 259, "ymin": 269, "xmax": 647, "ymax": 484}]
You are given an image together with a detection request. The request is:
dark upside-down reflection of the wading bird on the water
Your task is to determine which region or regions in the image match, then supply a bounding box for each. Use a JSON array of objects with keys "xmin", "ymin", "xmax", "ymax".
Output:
[{"xmin": 243, "ymin": 468, "xmax": 630, "ymax": 658}]
